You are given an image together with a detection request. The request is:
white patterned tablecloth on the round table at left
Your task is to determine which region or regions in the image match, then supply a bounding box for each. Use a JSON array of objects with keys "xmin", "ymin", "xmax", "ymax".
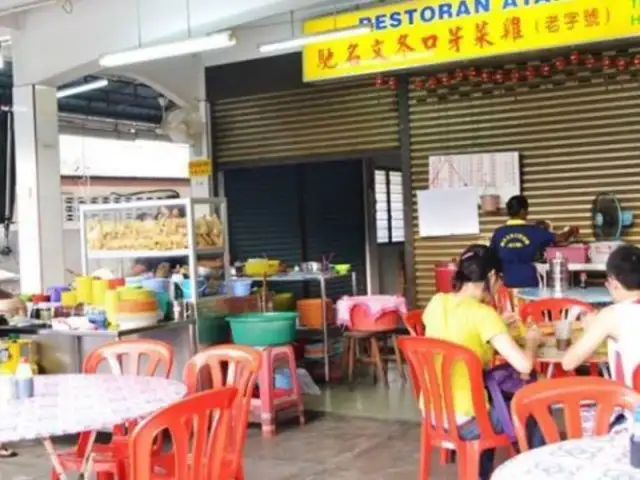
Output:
[{"xmin": 0, "ymin": 374, "xmax": 187, "ymax": 443}]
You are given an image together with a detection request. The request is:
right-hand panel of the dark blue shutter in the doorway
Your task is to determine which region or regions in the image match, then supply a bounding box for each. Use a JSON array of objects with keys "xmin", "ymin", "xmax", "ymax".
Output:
[{"xmin": 302, "ymin": 161, "xmax": 365, "ymax": 299}]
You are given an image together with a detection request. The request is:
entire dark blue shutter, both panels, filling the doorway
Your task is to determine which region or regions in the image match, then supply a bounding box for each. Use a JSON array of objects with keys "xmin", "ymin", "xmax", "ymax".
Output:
[{"xmin": 224, "ymin": 160, "xmax": 366, "ymax": 299}]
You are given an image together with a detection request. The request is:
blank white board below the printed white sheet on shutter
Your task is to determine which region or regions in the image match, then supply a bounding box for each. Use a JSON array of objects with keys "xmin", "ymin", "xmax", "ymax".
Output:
[{"xmin": 416, "ymin": 187, "xmax": 480, "ymax": 237}]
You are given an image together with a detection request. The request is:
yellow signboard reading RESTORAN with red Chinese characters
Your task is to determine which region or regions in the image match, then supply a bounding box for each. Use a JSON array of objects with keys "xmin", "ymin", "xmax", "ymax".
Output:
[{"xmin": 303, "ymin": 0, "xmax": 640, "ymax": 81}]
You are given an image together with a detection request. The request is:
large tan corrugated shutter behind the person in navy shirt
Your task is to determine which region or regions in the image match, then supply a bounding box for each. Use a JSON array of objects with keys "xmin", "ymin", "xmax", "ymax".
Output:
[{"xmin": 410, "ymin": 76, "xmax": 640, "ymax": 305}]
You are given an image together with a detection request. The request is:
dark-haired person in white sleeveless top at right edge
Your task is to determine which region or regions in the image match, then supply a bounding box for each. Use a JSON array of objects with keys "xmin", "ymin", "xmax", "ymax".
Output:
[{"xmin": 562, "ymin": 245, "xmax": 640, "ymax": 387}]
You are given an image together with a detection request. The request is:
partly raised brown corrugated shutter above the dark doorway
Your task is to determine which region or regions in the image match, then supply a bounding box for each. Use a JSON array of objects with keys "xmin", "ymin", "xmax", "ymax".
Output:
[{"xmin": 213, "ymin": 78, "xmax": 399, "ymax": 164}]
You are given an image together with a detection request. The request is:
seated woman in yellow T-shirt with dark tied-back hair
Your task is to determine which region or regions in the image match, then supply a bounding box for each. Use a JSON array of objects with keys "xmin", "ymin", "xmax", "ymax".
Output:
[{"xmin": 423, "ymin": 246, "xmax": 542, "ymax": 479}]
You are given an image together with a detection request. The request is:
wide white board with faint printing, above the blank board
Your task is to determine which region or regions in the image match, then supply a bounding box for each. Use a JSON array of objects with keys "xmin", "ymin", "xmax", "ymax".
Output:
[{"xmin": 429, "ymin": 152, "xmax": 521, "ymax": 206}]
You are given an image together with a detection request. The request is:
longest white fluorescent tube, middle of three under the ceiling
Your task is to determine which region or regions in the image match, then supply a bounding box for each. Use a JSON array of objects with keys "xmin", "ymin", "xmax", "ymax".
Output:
[{"xmin": 100, "ymin": 30, "xmax": 236, "ymax": 67}]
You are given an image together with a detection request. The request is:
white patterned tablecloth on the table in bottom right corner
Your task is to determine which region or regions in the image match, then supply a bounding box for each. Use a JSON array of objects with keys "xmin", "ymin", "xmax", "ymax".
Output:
[{"xmin": 491, "ymin": 430, "xmax": 640, "ymax": 480}]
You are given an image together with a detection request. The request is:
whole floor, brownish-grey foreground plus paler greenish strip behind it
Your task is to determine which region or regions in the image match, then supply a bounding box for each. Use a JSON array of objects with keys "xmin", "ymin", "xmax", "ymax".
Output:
[{"xmin": 0, "ymin": 368, "xmax": 500, "ymax": 480}]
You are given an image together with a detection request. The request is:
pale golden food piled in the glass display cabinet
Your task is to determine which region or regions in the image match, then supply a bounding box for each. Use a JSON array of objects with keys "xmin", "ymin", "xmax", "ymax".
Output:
[{"xmin": 87, "ymin": 213, "xmax": 224, "ymax": 251}]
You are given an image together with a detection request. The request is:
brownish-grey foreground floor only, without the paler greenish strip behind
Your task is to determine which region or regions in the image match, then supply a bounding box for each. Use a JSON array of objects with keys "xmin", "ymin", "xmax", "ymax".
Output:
[{"xmin": 0, "ymin": 415, "xmax": 498, "ymax": 480}]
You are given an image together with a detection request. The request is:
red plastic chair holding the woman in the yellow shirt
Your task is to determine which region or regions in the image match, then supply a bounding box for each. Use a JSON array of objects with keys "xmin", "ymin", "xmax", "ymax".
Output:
[{"xmin": 398, "ymin": 337, "xmax": 511, "ymax": 480}]
